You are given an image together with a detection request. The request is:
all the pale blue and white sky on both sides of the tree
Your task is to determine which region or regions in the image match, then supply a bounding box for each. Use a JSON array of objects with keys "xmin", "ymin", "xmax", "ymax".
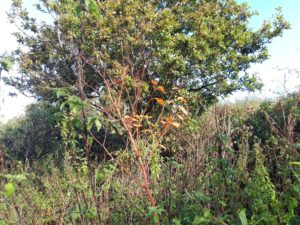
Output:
[{"xmin": 0, "ymin": 0, "xmax": 300, "ymax": 122}]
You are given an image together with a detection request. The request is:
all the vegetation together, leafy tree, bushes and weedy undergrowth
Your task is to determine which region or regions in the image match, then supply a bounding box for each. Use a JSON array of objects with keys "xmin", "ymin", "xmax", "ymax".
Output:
[{"xmin": 0, "ymin": 0, "xmax": 300, "ymax": 225}]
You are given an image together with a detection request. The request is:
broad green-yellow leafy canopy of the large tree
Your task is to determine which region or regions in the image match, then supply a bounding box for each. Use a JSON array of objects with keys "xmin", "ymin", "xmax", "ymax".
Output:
[{"xmin": 7, "ymin": 0, "xmax": 289, "ymax": 106}]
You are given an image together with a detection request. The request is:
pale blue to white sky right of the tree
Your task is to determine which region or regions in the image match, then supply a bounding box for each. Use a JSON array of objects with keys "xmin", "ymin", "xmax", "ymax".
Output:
[{"xmin": 231, "ymin": 0, "xmax": 300, "ymax": 99}]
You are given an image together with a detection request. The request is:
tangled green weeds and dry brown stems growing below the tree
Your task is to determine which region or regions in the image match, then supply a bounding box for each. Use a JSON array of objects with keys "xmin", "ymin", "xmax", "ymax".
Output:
[{"xmin": 0, "ymin": 95, "xmax": 300, "ymax": 225}]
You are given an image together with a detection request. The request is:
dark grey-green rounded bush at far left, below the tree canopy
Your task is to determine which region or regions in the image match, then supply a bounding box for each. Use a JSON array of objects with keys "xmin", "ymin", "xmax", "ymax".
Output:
[{"xmin": 0, "ymin": 103, "xmax": 62, "ymax": 167}]
